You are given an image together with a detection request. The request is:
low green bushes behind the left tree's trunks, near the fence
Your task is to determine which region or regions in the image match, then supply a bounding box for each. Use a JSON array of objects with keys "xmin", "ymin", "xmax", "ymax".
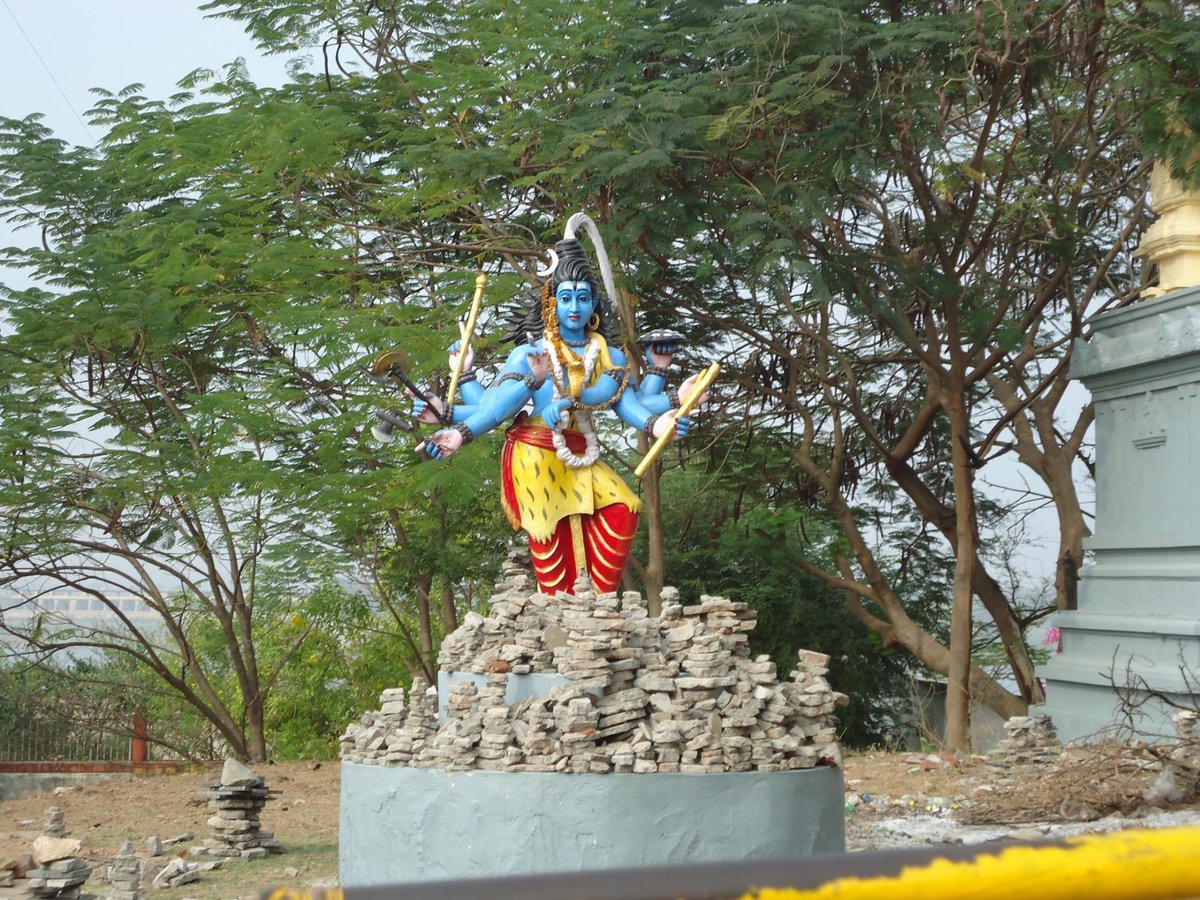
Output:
[{"xmin": 0, "ymin": 580, "xmax": 409, "ymax": 760}]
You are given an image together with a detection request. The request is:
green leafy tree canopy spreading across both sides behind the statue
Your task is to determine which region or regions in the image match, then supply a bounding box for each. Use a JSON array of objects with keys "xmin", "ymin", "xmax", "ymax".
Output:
[{"xmin": 0, "ymin": 0, "xmax": 1200, "ymax": 752}]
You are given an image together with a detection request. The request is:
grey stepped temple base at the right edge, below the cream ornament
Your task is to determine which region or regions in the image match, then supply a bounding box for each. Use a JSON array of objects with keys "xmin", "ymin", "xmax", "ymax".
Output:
[{"xmin": 1038, "ymin": 289, "xmax": 1200, "ymax": 740}]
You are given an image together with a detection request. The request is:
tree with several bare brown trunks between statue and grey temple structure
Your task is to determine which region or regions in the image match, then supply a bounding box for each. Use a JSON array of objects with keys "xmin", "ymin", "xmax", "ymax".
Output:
[{"xmin": 573, "ymin": 4, "xmax": 1194, "ymax": 746}]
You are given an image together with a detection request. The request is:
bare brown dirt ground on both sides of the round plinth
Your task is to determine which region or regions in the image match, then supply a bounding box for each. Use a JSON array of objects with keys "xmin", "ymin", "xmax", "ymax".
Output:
[{"xmin": 0, "ymin": 746, "xmax": 1200, "ymax": 900}]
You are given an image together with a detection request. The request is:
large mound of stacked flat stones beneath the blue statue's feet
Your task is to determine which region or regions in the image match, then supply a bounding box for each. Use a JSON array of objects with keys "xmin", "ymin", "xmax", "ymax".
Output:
[{"xmin": 342, "ymin": 578, "xmax": 846, "ymax": 774}]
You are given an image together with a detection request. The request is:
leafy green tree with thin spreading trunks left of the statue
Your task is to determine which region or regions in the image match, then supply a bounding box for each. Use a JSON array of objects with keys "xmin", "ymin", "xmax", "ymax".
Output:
[{"xmin": 0, "ymin": 65, "xmax": 496, "ymax": 761}]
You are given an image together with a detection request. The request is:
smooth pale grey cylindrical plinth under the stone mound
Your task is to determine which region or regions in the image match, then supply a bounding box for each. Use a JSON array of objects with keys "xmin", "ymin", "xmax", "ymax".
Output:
[{"xmin": 340, "ymin": 763, "xmax": 845, "ymax": 887}]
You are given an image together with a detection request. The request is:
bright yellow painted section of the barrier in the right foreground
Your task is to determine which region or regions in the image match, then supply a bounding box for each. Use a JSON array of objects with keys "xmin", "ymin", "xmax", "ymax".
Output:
[{"xmin": 743, "ymin": 828, "xmax": 1200, "ymax": 900}]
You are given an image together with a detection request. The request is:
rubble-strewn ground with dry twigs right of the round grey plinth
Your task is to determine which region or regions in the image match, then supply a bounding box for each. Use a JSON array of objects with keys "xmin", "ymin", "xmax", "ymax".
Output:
[{"xmin": 846, "ymin": 712, "xmax": 1200, "ymax": 851}]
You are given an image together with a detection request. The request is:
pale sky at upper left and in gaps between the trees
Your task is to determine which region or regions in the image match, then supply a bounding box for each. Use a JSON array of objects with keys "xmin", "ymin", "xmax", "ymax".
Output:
[{"xmin": 0, "ymin": 0, "xmax": 1090, "ymax": 600}]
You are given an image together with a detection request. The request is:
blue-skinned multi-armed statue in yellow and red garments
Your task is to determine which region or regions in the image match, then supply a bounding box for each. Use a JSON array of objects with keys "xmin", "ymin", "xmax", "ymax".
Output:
[{"xmin": 377, "ymin": 214, "xmax": 719, "ymax": 594}]
